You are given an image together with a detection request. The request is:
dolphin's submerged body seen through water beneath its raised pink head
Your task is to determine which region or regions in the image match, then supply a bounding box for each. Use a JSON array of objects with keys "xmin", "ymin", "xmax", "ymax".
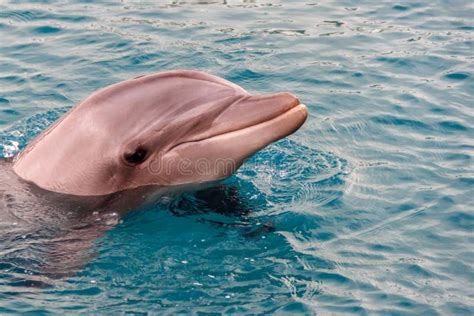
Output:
[{"xmin": 0, "ymin": 160, "xmax": 254, "ymax": 282}]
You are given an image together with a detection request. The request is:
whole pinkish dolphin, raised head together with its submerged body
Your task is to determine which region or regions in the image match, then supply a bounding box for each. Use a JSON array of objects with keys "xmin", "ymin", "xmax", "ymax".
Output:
[{"xmin": 0, "ymin": 70, "xmax": 307, "ymax": 278}]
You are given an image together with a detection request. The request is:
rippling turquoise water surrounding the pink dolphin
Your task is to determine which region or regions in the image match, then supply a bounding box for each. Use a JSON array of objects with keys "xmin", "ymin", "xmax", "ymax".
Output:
[{"xmin": 0, "ymin": 0, "xmax": 474, "ymax": 315}]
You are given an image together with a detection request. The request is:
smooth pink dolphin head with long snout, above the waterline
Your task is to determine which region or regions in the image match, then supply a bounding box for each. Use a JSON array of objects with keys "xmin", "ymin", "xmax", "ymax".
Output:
[{"xmin": 13, "ymin": 70, "xmax": 308, "ymax": 196}]
